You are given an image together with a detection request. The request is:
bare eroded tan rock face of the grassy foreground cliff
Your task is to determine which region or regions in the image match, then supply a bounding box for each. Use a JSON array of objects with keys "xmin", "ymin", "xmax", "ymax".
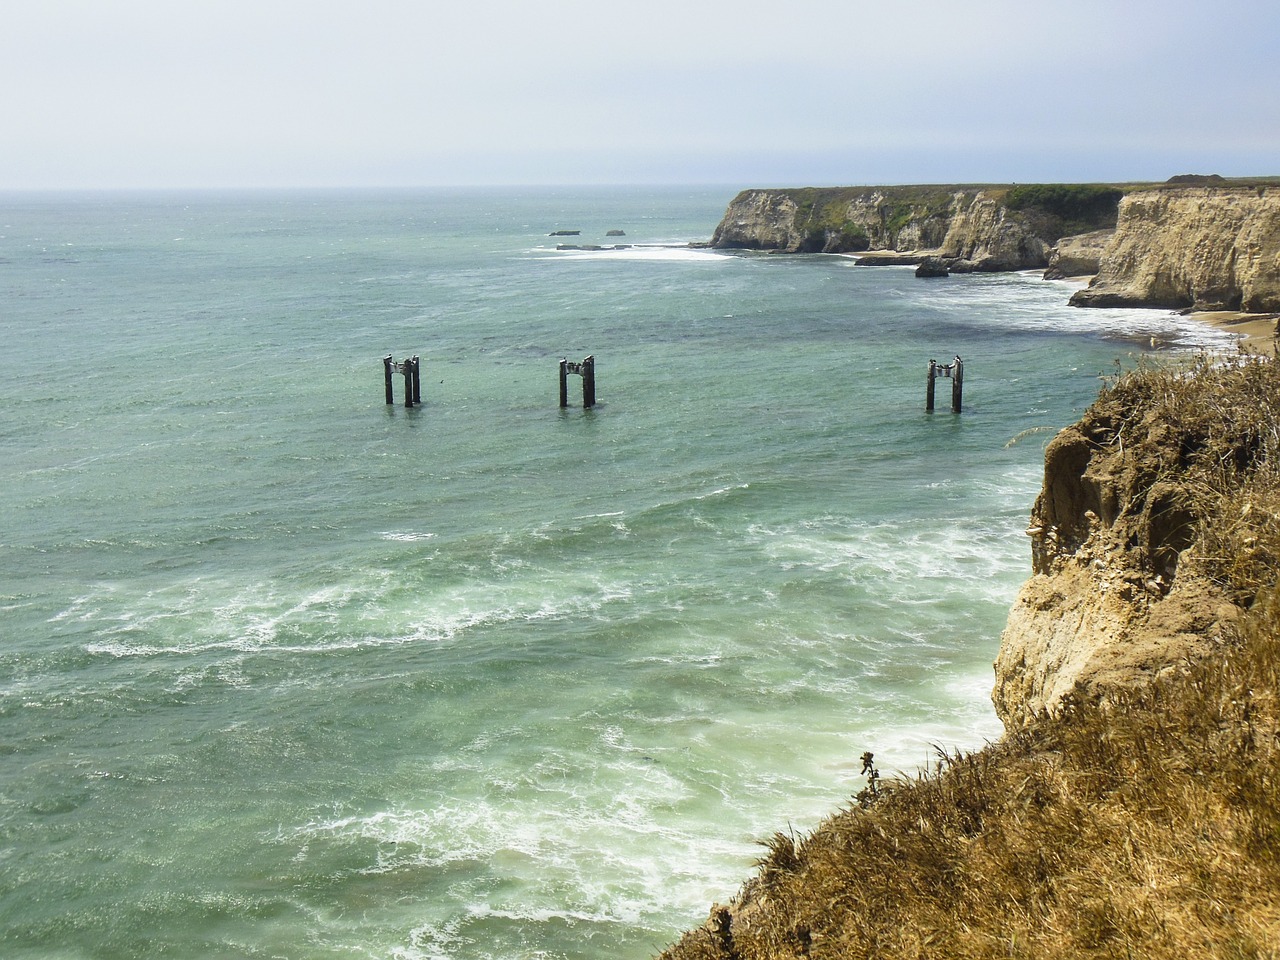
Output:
[{"xmin": 992, "ymin": 391, "xmax": 1242, "ymax": 728}]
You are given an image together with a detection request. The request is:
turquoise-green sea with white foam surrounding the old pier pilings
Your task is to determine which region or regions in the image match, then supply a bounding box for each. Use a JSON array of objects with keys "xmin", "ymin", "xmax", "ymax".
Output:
[{"xmin": 0, "ymin": 188, "xmax": 1228, "ymax": 959}]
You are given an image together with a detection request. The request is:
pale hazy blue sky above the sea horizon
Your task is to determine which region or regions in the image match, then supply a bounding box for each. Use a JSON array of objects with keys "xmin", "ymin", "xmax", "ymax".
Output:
[{"xmin": 0, "ymin": 0, "xmax": 1280, "ymax": 189}]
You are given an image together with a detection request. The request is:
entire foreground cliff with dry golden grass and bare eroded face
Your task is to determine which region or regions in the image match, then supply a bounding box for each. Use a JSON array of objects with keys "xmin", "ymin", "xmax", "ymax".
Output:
[{"xmin": 663, "ymin": 355, "xmax": 1280, "ymax": 960}]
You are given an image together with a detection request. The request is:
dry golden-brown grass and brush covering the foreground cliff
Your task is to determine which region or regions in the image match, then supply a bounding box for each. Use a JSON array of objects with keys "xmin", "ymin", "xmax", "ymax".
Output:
[{"xmin": 666, "ymin": 356, "xmax": 1280, "ymax": 960}]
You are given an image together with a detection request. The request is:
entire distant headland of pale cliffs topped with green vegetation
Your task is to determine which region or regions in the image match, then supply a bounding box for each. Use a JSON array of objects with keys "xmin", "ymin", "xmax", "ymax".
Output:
[{"xmin": 710, "ymin": 177, "xmax": 1280, "ymax": 311}]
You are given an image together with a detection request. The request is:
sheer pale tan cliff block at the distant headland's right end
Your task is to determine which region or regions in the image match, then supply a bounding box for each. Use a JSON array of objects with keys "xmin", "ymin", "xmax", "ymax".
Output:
[{"xmin": 1071, "ymin": 186, "xmax": 1280, "ymax": 312}]
